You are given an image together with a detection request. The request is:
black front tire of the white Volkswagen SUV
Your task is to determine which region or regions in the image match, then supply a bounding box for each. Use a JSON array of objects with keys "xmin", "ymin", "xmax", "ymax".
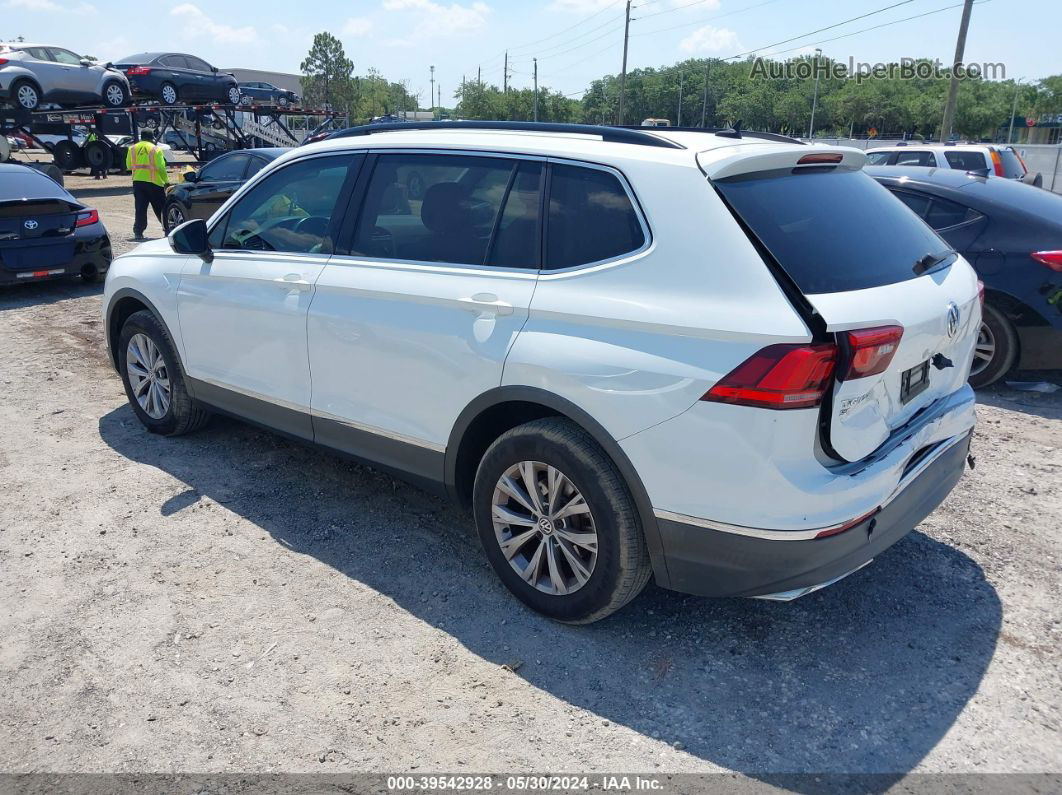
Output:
[{"xmin": 118, "ymin": 310, "xmax": 210, "ymax": 436}]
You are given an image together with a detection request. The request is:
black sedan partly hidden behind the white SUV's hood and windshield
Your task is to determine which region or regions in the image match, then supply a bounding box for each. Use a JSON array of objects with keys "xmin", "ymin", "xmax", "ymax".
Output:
[{"xmin": 164, "ymin": 148, "xmax": 288, "ymax": 231}]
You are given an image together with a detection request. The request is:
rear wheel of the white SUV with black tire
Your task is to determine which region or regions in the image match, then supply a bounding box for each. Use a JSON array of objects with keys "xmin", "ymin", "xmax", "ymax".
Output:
[{"xmin": 473, "ymin": 417, "xmax": 652, "ymax": 624}]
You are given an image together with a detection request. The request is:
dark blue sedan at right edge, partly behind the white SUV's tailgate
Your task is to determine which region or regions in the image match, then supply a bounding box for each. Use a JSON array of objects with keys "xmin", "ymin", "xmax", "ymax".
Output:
[{"xmin": 867, "ymin": 166, "xmax": 1062, "ymax": 387}]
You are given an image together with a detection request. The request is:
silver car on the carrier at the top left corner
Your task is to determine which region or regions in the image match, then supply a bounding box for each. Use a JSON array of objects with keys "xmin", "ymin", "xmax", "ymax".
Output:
[{"xmin": 0, "ymin": 41, "xmax": 130, "ymax": 110}]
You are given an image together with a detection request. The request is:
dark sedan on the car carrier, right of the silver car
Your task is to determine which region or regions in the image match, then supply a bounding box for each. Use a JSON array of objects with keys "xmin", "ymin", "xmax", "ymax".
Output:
[{"xmin": 117, "ymin": 52, "xmax": 240, "ymax": 105}]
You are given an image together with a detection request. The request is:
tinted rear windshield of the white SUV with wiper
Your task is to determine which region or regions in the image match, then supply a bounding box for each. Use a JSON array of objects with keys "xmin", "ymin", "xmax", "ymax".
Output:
[{"xmin": 715, "ymin": 169, "xmax": 948, "ymax": 294}]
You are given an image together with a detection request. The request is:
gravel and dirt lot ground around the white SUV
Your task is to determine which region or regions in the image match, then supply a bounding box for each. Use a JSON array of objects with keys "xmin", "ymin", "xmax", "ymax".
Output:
[{"xmin": 0, "ymin": 177, "xmax": 1062, "ymax": 778}]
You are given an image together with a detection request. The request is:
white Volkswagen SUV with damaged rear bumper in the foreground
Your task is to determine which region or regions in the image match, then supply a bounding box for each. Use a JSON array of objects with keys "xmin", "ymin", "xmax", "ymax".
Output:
[{"xmin": 104, "ymin": 122, "xmax": 980, "ymax": 622}]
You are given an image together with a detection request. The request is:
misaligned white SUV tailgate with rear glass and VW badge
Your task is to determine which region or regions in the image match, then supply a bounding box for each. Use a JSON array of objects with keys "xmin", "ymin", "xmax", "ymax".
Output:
[{"xmin": 709, "ymin": 153, "xmax": 980, "ymax": 461}]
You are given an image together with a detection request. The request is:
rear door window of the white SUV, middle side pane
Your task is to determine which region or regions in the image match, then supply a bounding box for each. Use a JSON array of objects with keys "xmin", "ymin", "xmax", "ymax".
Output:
[{"xmin": 350, "ymin": 154, "xmax": 517, "ymax": 265}]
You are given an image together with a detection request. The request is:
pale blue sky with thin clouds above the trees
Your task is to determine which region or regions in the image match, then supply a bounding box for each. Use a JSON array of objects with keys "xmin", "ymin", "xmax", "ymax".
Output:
[{"xmin": 0, "ymin": 0, "xmax": 1062, "ymax": 106}]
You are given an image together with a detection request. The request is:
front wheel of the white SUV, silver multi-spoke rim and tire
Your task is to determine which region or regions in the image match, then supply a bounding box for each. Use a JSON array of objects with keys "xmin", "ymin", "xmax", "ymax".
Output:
[{"xmin": 118, "ymin": 310, "xmax": 210, "ymax": 436}]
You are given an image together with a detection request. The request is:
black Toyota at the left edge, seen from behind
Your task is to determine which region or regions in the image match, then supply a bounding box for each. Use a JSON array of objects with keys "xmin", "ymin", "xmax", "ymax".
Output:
[{"xmin": 0, "ymin": 163, "xmax": 110, "ymax": 284}]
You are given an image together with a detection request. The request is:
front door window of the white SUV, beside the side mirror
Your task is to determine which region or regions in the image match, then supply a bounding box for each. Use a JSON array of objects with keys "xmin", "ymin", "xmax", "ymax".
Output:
[{"xmin": 210, "ymin": 155, "xmax": 361, "ymax": 254}]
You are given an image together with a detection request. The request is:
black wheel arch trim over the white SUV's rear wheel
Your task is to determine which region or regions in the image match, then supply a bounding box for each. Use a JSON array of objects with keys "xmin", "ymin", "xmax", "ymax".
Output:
[{"xmin": 443, "ymin": 385, "xmax": 670, "ymax": 587}]
